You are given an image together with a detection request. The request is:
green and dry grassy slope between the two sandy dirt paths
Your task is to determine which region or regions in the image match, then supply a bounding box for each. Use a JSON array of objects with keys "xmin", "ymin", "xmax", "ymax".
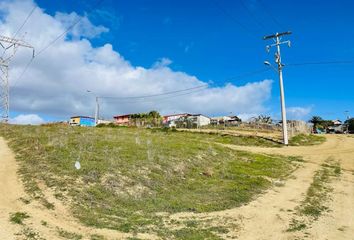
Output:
[{"xmin": 0, "ymin": 125, "xmax": 299, "ymax": 239}]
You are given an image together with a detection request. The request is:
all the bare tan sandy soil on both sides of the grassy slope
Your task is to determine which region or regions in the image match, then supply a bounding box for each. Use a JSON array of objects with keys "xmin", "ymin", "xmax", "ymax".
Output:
[{"xmin": 0, "ymin": 135, "xmax": 354, "ymax": 240}]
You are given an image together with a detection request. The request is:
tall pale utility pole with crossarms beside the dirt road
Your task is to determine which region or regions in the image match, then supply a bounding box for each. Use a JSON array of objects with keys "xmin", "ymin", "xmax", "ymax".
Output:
[{"xmin": 263, "ymin": 31, "xmax": 291, "ymax": 145}]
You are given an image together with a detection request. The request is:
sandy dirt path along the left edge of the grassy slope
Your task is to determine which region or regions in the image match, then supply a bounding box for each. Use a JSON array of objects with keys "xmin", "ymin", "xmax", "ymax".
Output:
[{"xmin": 0, "ymin": 137, "xmax": 156, "ymax": 240}]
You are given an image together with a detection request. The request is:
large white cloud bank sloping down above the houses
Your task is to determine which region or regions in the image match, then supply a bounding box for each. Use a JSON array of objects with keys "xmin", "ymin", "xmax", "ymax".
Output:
[{"xmin": 0, "ymin": 0, "xmax": 272, "ymax": 120}]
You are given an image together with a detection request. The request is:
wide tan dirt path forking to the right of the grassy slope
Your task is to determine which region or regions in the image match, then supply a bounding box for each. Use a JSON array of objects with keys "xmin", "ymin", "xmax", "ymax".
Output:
[{"xmin": 174, "ymin": 135, "xmax": 354, "ymax": 240}]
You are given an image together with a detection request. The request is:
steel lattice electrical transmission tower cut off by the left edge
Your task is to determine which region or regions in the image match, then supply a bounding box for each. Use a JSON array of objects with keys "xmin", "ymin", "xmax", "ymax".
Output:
[{"xmin": 0, "ymin": 35, "xmax": 34, "ymax": 122}]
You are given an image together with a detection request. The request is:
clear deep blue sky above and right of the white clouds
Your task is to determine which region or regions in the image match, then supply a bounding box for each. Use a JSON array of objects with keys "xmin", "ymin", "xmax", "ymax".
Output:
[{"xmin": 2, "ymin": 0, "xmax": 354, "ymax": 123}]
